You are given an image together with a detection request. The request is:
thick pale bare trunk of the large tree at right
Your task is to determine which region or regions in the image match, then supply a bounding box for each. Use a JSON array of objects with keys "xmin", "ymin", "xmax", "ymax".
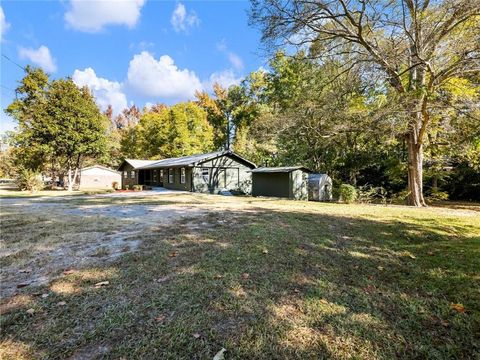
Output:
[{"xmin": 406, "ymin": 131, "xmax": 427, "ymax": 206}]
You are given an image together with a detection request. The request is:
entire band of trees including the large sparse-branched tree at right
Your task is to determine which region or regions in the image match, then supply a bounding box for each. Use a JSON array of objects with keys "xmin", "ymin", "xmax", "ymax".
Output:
[{"xmin": 1, "ymin": 0, "xmax": 480, "ymax": 202}]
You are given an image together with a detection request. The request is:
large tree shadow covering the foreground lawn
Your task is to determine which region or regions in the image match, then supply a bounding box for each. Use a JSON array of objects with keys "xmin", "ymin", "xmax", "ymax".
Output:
[{"xmin": 2, "ymin": 207, "xmax": 480, "ymax": 359}]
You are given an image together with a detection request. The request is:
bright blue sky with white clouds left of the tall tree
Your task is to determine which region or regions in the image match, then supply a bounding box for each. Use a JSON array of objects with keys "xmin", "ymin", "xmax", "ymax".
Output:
[{"xmin": 0, "ymin": 0, "xmax": 265, "ymax": 132}]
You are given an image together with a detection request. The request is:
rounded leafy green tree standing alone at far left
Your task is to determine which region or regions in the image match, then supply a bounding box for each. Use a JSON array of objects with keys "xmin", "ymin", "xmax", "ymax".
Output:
[{"xmin": 7, "ymin": 68, "xmax": 107, "ymax": 191}]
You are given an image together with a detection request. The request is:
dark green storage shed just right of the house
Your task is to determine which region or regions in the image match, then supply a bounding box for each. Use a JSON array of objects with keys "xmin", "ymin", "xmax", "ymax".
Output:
[{"xmin": 251, "ymin": 166, "xmax": 312, "ymax": 200}]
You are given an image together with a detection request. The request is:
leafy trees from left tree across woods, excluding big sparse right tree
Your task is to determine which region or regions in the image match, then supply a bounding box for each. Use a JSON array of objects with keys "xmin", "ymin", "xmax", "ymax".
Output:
[{"xmin": 1, "ymin": 52, "xmax": 480, "ymax": 200}]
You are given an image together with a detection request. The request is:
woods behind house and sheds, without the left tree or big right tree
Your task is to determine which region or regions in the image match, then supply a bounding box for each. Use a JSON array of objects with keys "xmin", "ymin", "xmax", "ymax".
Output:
[{"xmin": 109, "ymin": 52, "xmax": 480, "ymax": 200}]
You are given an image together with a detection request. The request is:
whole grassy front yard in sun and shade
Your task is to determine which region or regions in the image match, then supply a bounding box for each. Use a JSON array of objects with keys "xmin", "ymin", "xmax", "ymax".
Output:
[{"xmin": 0, "ymin": 194, "xmax": 480, "ymax": 359}]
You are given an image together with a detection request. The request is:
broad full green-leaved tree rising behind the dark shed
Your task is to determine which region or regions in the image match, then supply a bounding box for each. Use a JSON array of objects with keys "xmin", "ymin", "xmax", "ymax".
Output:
[{"xmin": 265, "ymin": 52, "xmax": 395, "ymax": 186}]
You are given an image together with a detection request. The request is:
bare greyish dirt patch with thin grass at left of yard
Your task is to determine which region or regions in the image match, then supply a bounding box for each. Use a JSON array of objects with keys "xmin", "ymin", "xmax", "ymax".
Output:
[{"xmin": 0, "ymin": 194, "xmax": 208, "ymax": 298}]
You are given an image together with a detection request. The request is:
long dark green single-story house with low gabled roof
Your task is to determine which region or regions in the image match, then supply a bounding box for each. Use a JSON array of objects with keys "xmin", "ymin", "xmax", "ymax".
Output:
[{"xmin": 118, "ymin": 150, "xmax": 256, "ymax": 194}]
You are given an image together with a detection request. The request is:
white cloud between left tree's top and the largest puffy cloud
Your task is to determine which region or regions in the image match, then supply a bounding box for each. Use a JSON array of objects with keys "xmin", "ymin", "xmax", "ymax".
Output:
[{"xmin": 72, "ymin": 68, "xmax": 127, "ymax": 115}]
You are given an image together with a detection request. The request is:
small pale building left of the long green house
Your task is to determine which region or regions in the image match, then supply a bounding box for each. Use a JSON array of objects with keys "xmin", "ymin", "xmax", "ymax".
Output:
[{"xmin": 77, "ymin": 165, "xmax": 122, "ymax": 190}]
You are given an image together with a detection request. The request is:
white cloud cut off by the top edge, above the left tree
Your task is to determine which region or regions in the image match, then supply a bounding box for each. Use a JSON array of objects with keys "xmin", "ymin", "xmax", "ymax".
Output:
[{"xmin": 65, "ymin": 0, "xmax": 145, "ymax": 33}]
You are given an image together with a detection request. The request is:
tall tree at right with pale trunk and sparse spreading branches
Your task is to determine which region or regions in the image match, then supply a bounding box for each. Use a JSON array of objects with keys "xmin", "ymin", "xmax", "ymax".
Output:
[{"xmin": 250, "ymin": 0, "xmax": 480, "ymax": 206}]
